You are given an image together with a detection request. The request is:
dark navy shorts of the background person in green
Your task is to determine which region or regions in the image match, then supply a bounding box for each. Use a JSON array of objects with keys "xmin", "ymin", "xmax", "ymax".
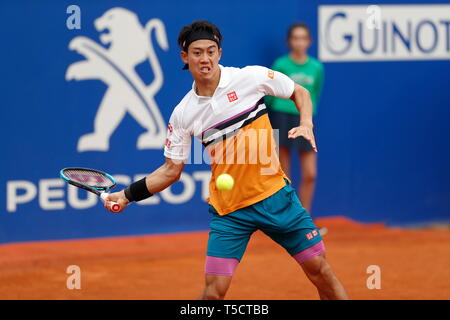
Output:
[{"xmin": 269, "ymin": 110, "xmax": 314, "ymax": 152}]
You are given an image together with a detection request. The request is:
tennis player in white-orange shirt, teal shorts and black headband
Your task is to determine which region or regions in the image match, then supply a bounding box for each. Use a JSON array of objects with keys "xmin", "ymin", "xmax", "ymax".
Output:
[{"xmin": 105, "ymin": 21, "xmax": 347, "ymax": 299}]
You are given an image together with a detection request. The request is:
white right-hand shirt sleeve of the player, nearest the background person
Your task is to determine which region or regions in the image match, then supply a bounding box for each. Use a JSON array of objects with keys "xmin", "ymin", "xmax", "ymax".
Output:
[{"xmin": 248, "ymin": 66, "xmax": 295, "ymax": 99}]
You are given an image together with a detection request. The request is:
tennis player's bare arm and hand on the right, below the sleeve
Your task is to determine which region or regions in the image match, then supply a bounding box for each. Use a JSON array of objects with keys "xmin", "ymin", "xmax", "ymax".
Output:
[{"xmin": 288, "ymin": 84, "xmax": 317, "ymax": 152}]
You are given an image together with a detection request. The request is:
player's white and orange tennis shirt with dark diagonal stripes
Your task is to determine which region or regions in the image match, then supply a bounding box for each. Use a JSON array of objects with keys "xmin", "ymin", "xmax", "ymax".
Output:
[{"xmin": 164, "ymin": 65, "xmax": 294, "ymax": 215}]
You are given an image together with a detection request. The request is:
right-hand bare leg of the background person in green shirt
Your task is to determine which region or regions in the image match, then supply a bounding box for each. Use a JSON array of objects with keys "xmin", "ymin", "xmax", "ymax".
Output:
[{"xmin": 298, "ymin": 151, "xmax": 317, "ymax": 213}]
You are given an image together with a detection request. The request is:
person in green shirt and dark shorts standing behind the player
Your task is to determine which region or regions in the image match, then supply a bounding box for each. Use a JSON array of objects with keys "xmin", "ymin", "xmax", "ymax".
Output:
[{"xmin": 266, "ymin": 22, "xmax": 327, "ymax": 234}]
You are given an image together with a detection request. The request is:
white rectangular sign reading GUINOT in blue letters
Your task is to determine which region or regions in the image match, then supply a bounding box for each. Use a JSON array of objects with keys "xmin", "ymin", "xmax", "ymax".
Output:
[{"xmin": 319, "ymin": 5, "xmax": 450, "ymax": 61}]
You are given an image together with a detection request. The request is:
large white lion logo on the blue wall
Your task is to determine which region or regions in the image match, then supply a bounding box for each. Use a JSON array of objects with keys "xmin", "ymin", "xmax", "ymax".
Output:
[{"xmin": 66, "ymin": 8, "xmax": 169, "ymax": 152}]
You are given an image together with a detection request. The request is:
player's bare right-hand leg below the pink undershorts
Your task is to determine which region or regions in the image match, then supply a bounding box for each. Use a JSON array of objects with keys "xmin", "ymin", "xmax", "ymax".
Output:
[{"xmin": 301, "ymin": 253, "xmax": 348, "ymax": 300}]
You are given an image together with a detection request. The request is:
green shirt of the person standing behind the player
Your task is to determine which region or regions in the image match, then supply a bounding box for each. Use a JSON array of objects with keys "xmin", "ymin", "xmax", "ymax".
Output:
[{"xmin": 265, "ymin": 55, "xmax": 323, "ymax": 115}]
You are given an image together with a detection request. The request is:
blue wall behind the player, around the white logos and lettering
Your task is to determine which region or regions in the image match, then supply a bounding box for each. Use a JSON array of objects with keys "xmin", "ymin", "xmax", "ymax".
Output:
[{"xmin": 0, "ymin": 0, "xmax": 450, "ymax": 243}]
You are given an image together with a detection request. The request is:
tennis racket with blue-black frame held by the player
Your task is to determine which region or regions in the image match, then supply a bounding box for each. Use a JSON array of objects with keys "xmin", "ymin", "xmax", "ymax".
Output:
[{"xmin": 59, "ymin": 168, "xmax": 120, "ymax": 212}]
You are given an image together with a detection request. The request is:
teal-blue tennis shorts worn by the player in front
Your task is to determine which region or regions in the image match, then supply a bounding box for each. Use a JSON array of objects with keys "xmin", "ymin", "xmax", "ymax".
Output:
[{"xmin": 207, "ymin": 184, "xmax": 322, "ymax": 261}]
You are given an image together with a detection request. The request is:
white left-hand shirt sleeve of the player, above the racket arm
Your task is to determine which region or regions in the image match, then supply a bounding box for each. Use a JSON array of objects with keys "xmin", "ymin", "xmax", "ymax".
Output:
[{"xmin": 164, "ymin": 109, "xmax": 191, "ymax": 160}]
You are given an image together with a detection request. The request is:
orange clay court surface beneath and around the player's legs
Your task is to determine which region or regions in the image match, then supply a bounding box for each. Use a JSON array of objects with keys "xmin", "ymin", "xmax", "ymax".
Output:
[{"xmin": 0, "ymin": 217, "xmax": 450, "ymax": 300}]
